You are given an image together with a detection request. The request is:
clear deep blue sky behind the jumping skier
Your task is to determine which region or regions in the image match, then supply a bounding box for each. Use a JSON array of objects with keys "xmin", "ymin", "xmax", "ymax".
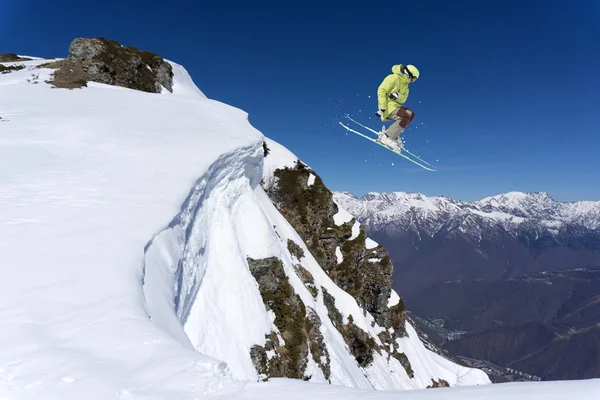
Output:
[{"xmin": 0, "ymin": 0, "xmax": 600, "ymax": 201}]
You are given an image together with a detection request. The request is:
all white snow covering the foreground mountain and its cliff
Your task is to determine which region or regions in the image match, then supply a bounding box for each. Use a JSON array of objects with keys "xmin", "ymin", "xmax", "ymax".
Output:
[{"xmin": 12, "ymin": 54, "xmax": 600, "ymax": 400}]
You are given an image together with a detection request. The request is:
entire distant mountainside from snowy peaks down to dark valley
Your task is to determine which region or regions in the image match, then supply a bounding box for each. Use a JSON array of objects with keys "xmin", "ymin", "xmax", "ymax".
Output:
[{"xmin": 334, "ymin": 192, "xmax": 600, "ymax": 379}]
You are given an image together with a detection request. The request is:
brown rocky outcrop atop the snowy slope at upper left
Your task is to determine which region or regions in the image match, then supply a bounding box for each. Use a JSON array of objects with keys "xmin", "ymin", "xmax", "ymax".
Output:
[{"xmin": 46, "ymin": 38, "xmax": 173, "ymax": 93}]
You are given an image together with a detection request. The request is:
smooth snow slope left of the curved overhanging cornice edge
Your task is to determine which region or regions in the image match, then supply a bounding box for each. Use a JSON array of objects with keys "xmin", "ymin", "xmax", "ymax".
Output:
[{"xmin": 0, "ymin": 57, "xmax": 255, "ymax": 399}]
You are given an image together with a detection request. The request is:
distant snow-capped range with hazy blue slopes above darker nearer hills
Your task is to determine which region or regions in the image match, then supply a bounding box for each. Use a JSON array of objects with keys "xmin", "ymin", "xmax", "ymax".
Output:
[{"xmin": 334, "ymin": 192, "xmax": 600, "ymax": 294}]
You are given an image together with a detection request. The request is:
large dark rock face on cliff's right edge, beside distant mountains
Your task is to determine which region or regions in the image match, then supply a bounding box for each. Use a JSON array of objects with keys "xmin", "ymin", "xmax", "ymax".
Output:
[{"xmin": 265, "ymin": 163, "xmax": 396, "ymax": 329}]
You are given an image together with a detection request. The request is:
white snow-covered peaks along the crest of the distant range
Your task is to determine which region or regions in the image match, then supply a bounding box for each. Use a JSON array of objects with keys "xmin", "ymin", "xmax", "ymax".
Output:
[{"xmin": 335, "ymin": 192, "xmax": 600, "ymax": 236}]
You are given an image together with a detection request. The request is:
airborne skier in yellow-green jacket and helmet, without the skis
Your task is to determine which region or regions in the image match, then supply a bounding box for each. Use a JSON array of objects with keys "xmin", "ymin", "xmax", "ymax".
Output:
[{"xmin": 375, "ymin": 64, "xmax": 419, "ymax": 151}]
